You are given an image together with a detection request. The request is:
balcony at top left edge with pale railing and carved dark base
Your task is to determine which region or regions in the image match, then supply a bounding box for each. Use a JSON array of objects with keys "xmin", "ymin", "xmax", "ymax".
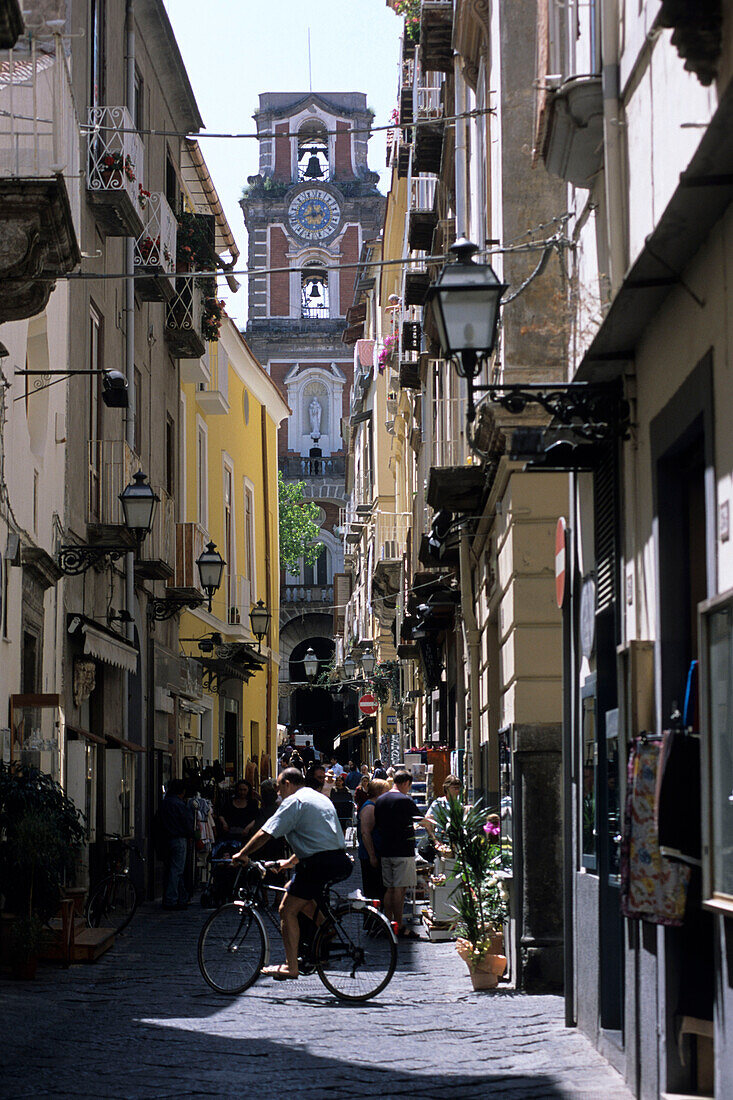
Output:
[{"xmin": 0, "ymin": 48, "xmax": 81, "ymax": 323}]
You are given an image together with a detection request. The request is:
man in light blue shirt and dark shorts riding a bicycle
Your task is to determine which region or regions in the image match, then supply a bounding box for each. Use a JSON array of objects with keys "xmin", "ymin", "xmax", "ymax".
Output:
[{"xmin": 232, "ymin": 768, "xmax": 352, "ymax": 981}]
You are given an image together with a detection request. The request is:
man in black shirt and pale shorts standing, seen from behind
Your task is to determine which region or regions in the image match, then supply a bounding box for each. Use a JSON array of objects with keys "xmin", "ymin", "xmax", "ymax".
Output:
[{"xmin": 374, "ymin": 769, "xmax": 425, "ymax": 939}]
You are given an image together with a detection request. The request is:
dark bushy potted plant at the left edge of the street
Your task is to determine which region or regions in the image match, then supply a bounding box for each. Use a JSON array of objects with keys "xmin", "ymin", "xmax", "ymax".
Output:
[{"xmin": 0, "ymin": 765, "xmax": 85, "ymax": 977}]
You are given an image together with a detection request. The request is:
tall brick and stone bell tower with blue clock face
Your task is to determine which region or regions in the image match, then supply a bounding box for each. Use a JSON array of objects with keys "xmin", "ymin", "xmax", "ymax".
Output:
[{"xmin": 241, "ymin": 92, "xmax": 385, "ymax": 752}]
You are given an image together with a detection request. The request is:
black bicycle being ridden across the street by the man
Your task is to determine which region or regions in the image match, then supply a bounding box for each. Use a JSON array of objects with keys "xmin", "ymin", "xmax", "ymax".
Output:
[{"xmin": 198, "ymin": 860, "xmax": 397, "ymax": 1001}]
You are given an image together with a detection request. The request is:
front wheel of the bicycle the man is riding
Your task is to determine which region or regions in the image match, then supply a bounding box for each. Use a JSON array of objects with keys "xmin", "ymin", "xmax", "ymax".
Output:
[{"xmin": 198, "ymin": 901, "xmax": 267, "ymax": 997}]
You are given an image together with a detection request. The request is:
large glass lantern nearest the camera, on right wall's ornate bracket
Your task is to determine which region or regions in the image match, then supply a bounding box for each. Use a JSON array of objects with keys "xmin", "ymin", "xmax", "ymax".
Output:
[{"xmin": 427, "ymin": 237, "xmax": 506, "ymax": 420}]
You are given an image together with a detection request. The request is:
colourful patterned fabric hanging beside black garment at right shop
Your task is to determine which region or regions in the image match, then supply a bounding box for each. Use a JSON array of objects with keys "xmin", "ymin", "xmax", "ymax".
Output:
[{"xmin": 621, "ymin": 737, "xmax": 691, "ymax": 925}]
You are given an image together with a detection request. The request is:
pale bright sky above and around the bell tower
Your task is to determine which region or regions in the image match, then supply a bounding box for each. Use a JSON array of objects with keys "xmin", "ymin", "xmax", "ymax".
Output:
[{"xmin": 164, "ymin": 0, "xmax": 402, "ymax": 326}]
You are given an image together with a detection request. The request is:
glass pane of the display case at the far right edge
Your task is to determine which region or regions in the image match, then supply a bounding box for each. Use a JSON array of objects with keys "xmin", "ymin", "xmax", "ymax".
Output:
[{"xmin": 709, "ymin": 606, "xmax": 733, "ymax": 897}]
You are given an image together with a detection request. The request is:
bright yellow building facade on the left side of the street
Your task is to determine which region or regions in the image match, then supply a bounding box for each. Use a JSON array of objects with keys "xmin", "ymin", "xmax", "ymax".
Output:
[{"xmin": 174, "ymin": 315, "xmax": 289, "ymax": 781}]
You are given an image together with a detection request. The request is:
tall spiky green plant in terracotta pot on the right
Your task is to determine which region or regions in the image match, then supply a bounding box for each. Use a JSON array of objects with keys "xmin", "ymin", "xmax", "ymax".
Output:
[{"xmin": 434, "ymin": 799, "xmax": 507, "ymax": 989}]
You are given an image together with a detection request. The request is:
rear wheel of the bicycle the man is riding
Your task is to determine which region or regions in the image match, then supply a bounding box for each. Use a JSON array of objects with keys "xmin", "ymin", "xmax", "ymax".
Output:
[{"xmin": 314, "ymin": 904, "xmax": 397, "ymax": 1001}]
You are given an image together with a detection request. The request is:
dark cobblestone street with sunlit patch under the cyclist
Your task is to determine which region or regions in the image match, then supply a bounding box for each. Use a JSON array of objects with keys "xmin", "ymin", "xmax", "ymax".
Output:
[{"xmin": 0, "ymin": 904, "xmax": 631, "ymax": 1100}]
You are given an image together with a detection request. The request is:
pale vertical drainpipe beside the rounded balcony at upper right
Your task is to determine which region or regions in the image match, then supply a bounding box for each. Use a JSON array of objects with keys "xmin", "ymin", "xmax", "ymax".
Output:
[{"xmin": 601, "ymin": 0, "xmax": 626, "ymax": 296}]
